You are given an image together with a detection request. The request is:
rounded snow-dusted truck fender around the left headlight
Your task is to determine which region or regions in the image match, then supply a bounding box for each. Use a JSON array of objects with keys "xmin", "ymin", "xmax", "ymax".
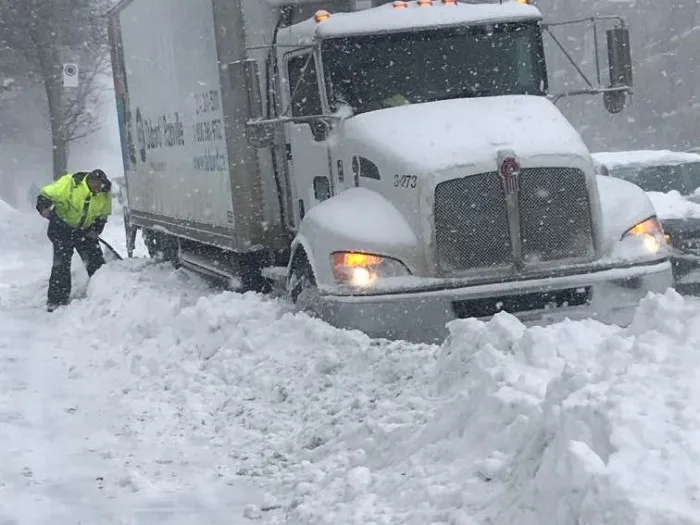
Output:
[{"xmin": 287, "ymin": 188, "xmax": 419, "ymax": 287}]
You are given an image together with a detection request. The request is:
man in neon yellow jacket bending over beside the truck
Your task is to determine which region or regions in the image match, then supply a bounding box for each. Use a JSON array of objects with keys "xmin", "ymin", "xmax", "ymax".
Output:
[{"xmin": 36, "ymin": 170, "xmax": 112, "ymax": 312}]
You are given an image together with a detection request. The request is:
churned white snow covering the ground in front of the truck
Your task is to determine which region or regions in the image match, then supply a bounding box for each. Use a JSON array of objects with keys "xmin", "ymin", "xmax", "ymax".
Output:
[{"xmin": 0, "ymin": 199, "xmax": 700, "ymax": 525}]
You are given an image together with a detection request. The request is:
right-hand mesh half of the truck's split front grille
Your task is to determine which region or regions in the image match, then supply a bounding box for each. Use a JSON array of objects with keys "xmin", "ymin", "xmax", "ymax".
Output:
[{"xmin": 518, "ymin": 168, "xmax": 595, "ymax": 265}]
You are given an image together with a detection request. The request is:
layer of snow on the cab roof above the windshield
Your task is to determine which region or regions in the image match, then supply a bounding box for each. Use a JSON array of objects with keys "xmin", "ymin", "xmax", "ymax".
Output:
[{"xmin": 290, "ymin": 0, "xmax": 542, "ymax": 39}]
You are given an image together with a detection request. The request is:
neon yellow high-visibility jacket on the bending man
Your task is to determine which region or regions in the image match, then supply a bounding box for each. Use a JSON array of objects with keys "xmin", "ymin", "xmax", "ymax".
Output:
[{"xmin": 39, "ymin": 172, "xmax": 112, "ymax": 230}]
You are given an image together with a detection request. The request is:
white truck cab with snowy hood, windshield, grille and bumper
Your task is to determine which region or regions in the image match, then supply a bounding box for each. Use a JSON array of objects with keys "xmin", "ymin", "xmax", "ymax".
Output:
[{"xmin": 245, "ymin": 1, "xmax": 672, "ymax": 335}]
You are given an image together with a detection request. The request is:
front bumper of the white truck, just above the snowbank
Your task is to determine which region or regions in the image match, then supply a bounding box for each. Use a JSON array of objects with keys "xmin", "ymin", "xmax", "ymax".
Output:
[{"xmin": 316, "ymin": 261, "xmax": 673, "ymax": 343}]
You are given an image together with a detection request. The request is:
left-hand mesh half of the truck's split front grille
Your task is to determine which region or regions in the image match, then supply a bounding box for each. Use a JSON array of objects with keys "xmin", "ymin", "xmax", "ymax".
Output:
[{"xmin": 435, "ymin": 172, "xmax": 513, "ymax": 272}]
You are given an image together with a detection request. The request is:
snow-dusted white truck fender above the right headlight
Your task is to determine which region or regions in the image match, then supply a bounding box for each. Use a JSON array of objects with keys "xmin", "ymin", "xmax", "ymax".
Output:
[{"xmin": 597, "ymin": 175, "xmax": 656, "ymax": 254}]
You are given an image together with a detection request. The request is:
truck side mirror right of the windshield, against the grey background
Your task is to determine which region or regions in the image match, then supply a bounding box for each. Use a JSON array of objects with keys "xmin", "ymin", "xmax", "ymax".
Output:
[{"xmin": 603, "ymin": 26, "xmax": 632, "ymax": 113}]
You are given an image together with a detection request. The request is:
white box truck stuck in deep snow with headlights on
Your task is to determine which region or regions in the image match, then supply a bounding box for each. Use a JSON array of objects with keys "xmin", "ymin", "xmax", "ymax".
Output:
[{"xmin": 110, "ymin": 0, "xmax": 673, "ymax": 341}]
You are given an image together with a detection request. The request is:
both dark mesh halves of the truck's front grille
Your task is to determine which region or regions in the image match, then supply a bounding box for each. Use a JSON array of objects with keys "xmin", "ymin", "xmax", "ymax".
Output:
[{"xmin": 435, "ymin": 168, "xmax": 595, "ymax": 273}]
